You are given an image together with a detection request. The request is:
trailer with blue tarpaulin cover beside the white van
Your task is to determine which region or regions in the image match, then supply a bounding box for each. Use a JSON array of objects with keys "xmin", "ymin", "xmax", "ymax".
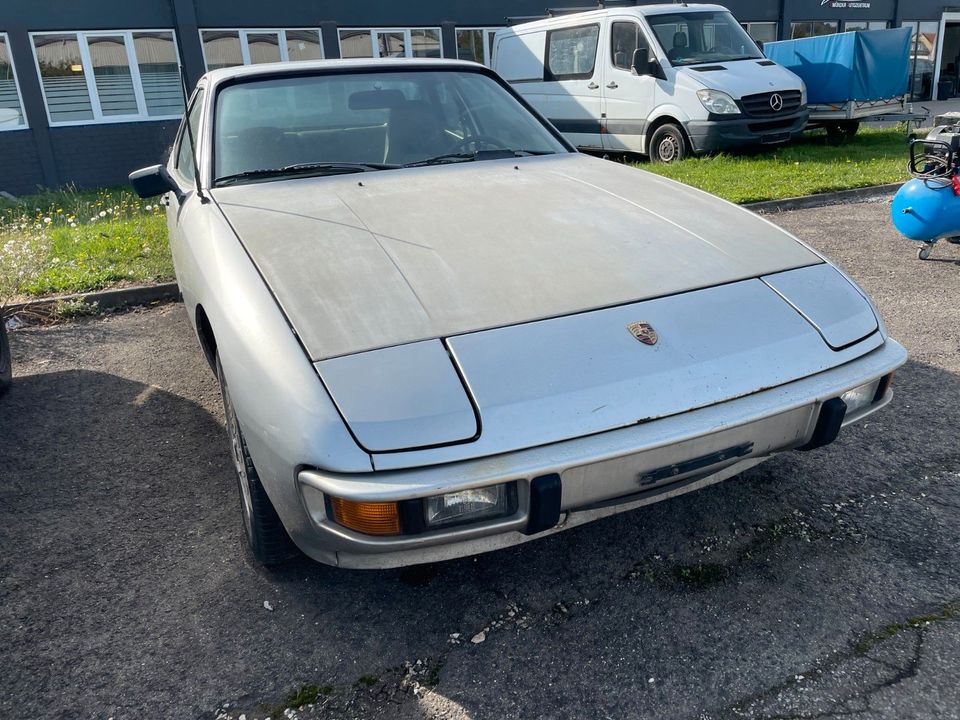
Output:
[{"xmin": 764, "ymin": 28, "xmax": 927, "ymax": 143}]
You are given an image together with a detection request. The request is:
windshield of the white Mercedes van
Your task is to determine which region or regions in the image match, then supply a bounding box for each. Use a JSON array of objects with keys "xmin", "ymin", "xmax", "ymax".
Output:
[{"xmin": 647, "ymin": 12, "xmax": 763, "ymax": 67}]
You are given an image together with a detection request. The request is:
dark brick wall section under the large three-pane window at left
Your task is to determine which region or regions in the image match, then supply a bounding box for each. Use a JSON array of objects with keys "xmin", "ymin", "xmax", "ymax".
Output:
[{"xmin": 50, "ymin": 121, "xmax": 179, "ymax": 187}]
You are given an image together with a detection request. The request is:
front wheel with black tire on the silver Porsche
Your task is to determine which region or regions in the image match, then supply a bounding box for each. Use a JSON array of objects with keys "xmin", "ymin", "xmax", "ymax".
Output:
[{"xmin": 215, "ymin": 354, "xmax": 297, "ymax": 565}]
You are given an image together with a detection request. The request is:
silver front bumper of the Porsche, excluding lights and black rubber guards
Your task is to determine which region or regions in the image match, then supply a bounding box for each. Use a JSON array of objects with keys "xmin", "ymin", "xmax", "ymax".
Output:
[{"xmin": 294, "ymin": 339, "xmax": 907, "ymax": 568}]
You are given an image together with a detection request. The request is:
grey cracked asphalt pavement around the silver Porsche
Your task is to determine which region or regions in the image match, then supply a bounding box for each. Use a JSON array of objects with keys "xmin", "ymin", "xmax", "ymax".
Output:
[{"xmin": 0, "ymin": 202, "xmax": 960, "ymax": 720}]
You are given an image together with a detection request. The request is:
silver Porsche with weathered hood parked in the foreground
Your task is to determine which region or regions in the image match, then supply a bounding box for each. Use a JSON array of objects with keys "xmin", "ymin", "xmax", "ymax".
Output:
[{"xmin": 131, "ymin": 60, "xmax": 906, "ymax": 568}]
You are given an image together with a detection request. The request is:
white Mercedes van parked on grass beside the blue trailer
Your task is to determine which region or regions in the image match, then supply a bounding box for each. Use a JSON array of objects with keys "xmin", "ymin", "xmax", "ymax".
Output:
[{"xmin": 492, "ymin": 3, "xmax": 809, "ymax": 162}]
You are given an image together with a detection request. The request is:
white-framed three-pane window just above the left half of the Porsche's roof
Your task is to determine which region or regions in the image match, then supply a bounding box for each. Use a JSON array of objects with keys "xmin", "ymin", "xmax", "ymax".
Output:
[{"xmin": 200, "ymin": 28, "xmax": 323, "ymax": 70}]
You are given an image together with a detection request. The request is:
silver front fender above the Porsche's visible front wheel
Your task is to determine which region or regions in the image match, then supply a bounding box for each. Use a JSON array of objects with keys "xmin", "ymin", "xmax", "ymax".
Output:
[{"xmin": 173, "ymin": 191, "xmax": 371, "ymax": 552}]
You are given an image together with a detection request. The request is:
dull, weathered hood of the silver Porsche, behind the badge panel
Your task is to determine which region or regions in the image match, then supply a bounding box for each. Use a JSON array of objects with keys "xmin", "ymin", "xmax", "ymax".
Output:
[{"xmin": 213, "ymin": 154, "xmax": 822, "ymax": 361}]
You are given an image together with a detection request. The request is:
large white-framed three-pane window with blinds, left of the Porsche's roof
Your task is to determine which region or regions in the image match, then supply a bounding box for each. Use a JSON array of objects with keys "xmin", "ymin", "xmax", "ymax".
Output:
[{"xmin": 31, "ymin": 30, "xmax": 183, "ymax": 125}]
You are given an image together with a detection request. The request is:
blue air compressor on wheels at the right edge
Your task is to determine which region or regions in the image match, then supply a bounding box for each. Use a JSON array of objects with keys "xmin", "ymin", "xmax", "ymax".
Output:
[{"xmin": 890, "ymin": 125, "xmax": 960, "ymax": 260}]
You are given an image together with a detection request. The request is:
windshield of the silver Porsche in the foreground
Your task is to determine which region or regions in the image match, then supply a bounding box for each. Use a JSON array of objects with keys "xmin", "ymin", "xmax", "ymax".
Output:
[{"xmin": 214, "ymin": 70, "xmax": 568, "ymax": 185}]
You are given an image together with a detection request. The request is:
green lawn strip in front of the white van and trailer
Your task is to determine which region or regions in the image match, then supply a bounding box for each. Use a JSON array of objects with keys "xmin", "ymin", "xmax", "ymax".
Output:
[{"xmin": 638, "ymin": 129, "xmax": 909, "ymax": 203}]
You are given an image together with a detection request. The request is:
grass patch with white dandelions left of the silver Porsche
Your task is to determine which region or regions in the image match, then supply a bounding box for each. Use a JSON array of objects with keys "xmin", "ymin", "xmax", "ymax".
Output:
[{"xmin": 0, "ymin": 188, "xmax": 173, "ymax": 304}]
